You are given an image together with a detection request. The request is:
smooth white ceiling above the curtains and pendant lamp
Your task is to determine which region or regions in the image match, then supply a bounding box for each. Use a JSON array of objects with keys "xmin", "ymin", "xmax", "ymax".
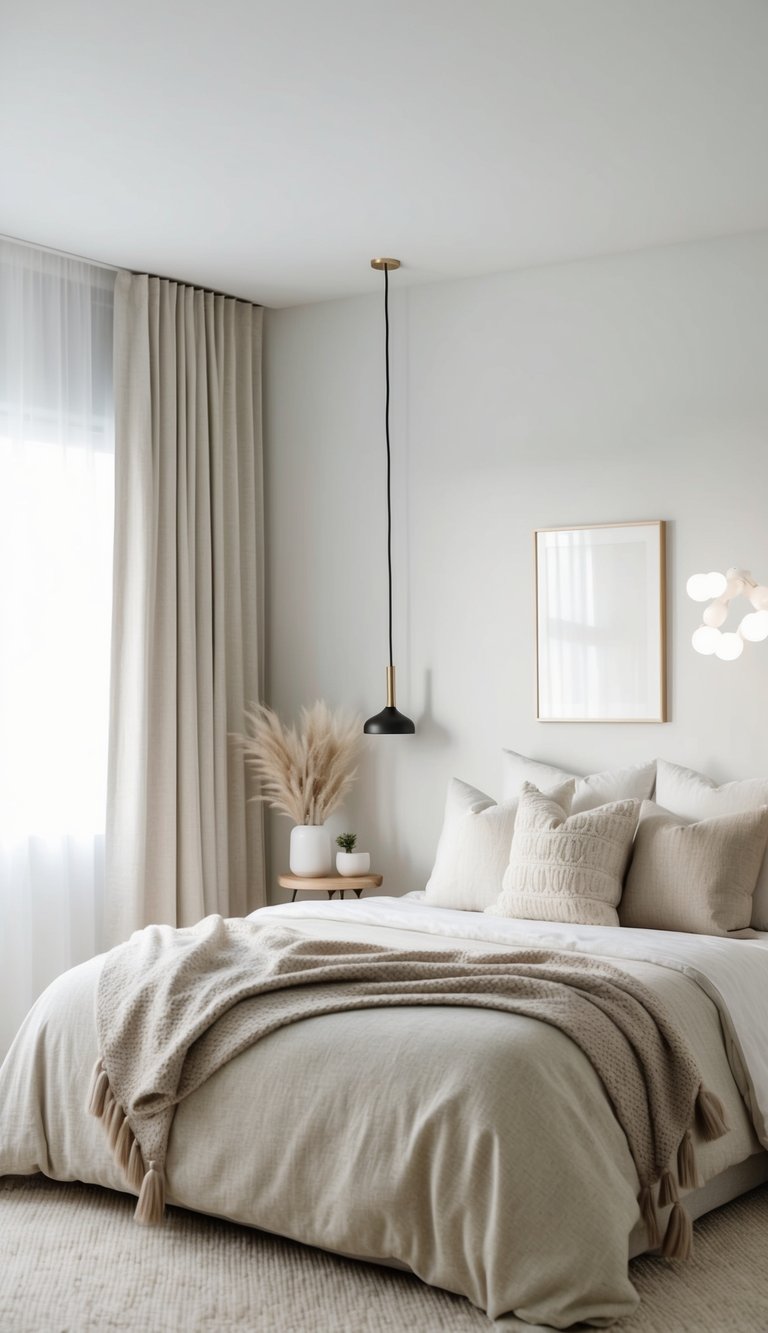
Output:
[{"xmin": 0, "ymin": 0, "xmax": 768, "ymax": 305}]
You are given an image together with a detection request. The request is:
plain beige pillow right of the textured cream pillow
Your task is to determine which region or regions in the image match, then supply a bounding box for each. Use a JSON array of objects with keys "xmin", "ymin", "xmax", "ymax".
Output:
[{"xmin": 619, "ymin": 801, "xmax": 768, "ymax": 938}]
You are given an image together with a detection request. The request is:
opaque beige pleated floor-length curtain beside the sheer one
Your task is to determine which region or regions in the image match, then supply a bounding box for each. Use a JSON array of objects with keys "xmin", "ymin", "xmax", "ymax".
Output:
[{"xmin": 107, "ymin": 273, "xmax": 267, "ymax": 944}]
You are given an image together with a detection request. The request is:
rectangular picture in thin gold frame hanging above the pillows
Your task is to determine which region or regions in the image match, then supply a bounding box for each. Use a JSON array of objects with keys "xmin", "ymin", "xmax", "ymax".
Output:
[{"xmin": 533, "ymin": 520, "xmax": 667, "ymax": 722}]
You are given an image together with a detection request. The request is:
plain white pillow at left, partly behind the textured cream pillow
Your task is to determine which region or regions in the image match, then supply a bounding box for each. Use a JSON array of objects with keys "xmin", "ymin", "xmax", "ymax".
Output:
[{"xmin": 427, "ymin": 777, "xmax": 573, "ymax": 912}]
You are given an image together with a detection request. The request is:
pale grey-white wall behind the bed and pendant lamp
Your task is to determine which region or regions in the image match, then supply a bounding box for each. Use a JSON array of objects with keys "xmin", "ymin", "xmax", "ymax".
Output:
[{"xmin": 265, "ymin": 233, "xmax": 768, "ymax": 901}]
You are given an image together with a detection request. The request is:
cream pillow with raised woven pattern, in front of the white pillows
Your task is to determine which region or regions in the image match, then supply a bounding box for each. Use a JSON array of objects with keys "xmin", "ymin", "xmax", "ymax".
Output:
[{"xmin": 487, "ymin": 782, "xmax": 640, "ymax": 925}]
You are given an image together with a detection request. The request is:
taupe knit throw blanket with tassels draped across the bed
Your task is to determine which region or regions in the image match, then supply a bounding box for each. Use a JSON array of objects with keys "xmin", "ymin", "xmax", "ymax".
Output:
[{"xmin": 88, "ymin": 916, "xmax": 728, "ymax": 1257}]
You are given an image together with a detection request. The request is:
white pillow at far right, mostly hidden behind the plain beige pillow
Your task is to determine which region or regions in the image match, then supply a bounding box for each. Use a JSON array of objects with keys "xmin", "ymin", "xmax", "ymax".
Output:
[{"xmin": 656, "ymin": 758, "xmax": 768, "ymax": 930}]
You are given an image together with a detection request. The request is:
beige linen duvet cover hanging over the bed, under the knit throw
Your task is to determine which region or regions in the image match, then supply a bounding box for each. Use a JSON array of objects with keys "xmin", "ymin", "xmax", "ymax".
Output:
[{"xmin": 0, "ymin": 900, "xmax": 768, "ymax": 1328}]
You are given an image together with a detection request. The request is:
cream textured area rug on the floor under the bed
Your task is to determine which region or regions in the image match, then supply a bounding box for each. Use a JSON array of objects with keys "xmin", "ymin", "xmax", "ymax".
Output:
[{"xmin": 0, "ymin": 1177, "xmax": 768, "ymax": 1333}]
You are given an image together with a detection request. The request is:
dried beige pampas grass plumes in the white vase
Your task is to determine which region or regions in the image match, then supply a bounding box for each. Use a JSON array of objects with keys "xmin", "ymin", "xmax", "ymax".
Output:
[{"xmin": 239, "ymin": 700, "xmax": 363, "ymax": 824}]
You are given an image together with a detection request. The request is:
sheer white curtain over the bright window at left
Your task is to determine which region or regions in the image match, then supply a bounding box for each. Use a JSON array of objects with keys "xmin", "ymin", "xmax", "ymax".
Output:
[{"xmin": 0, "ymin": 240, "xmax": 115, "ymax": 1057}]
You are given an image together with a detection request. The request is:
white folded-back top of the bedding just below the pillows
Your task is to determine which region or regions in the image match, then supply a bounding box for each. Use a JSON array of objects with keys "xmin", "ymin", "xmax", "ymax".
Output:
[{"xmin": 259, "ymin": 893, "xmax": 768, "ymax": 1148}]
